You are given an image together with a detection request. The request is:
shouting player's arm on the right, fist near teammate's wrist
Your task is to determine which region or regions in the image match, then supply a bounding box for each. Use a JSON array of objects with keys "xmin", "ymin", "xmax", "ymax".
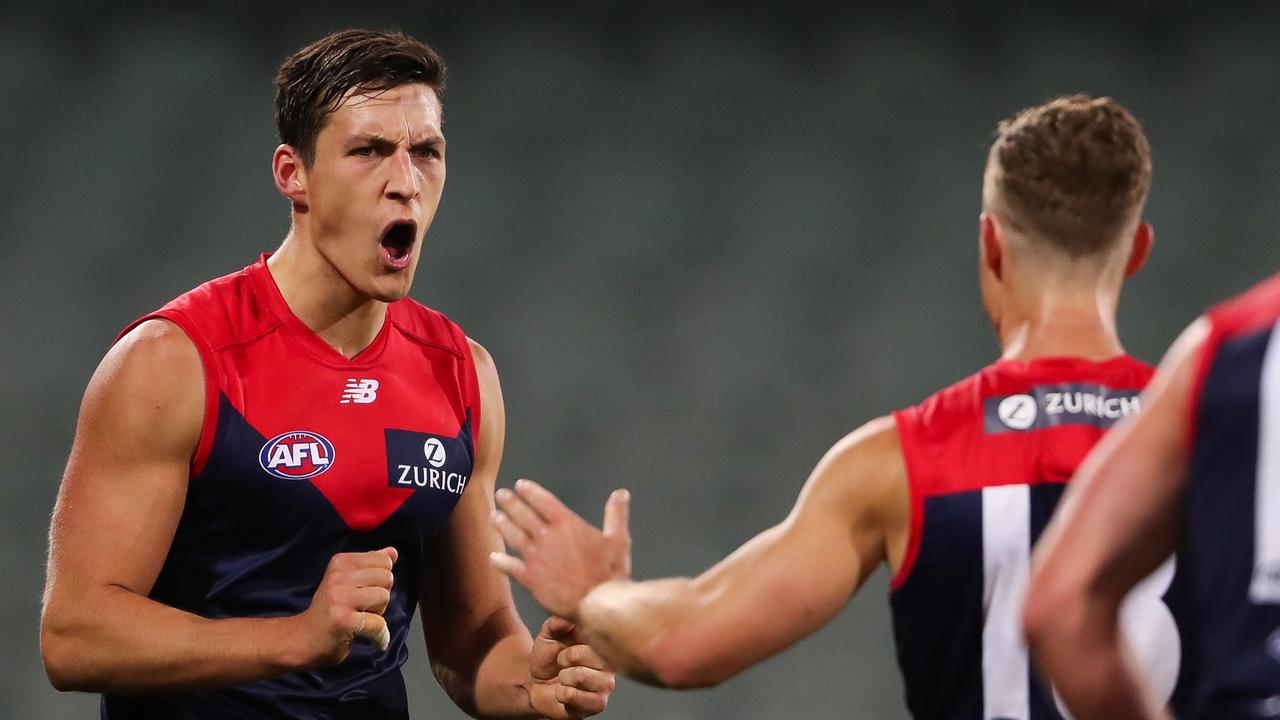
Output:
[{"xmin": 420, "ymin": 342, "xmax": 613, "ymax": 717}]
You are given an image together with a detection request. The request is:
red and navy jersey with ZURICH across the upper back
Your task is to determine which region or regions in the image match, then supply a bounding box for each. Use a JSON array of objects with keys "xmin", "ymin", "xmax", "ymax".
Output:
[{"xmin": 890, "ymin": 356, "xmax": 1180, "ymax": 720}]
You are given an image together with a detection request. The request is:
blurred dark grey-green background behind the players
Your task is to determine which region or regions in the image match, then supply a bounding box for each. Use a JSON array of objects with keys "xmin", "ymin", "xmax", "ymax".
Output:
[{"xmin": 0, "ymin": 0, "xmax": 1280, "ymax": 720}]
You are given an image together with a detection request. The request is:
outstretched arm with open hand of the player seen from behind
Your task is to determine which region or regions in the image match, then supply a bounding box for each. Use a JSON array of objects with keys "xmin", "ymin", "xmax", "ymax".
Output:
[{"xmin": 493, "ymin": 418, "xmax": 906, "ymax": 687}]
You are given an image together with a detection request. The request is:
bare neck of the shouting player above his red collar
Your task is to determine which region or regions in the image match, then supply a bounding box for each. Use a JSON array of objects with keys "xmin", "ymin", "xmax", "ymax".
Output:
[{"xmin": 266, "ymin": 225, "xmax": 387, "ymax": 359}]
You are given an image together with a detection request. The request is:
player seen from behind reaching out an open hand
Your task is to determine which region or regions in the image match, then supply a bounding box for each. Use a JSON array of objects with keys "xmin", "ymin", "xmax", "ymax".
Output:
[{"xmin": 493, "ymin": 96, "xmax": 1176, "ymax": 720}]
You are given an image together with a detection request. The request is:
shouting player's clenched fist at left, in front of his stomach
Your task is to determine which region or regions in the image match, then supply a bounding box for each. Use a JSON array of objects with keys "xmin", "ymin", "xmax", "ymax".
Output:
[{"xmin": 297, "ymin": 547, "xmax": 397, "ymax": 666}]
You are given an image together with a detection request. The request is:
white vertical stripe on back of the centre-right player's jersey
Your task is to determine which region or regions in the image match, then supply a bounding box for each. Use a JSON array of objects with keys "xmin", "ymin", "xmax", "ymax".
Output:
[{"xmin": 982, "ymin": 486, "xmax": 1032, "ymax": 720}]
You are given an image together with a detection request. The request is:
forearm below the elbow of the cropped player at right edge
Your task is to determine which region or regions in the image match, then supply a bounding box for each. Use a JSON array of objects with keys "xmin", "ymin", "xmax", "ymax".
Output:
[{"xmin": 1028, "ymin": 600, "xmax": 1169, "ymax": 720}]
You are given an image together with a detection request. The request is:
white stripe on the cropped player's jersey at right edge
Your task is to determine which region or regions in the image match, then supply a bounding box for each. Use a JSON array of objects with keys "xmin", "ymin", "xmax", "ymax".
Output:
[{"xmin": 1249, "ymin": 324, "xmax": 1280, "ymax": 603}]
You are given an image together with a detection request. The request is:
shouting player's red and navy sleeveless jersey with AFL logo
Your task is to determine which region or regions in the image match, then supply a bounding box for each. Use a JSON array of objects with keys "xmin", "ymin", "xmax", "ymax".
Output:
[{"xmin": 102, "ymin": 256, "xmax": 480, "ymax": 720}]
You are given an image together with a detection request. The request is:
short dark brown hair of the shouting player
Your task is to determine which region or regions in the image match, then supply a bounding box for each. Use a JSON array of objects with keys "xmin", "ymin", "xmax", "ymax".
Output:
[{"xmin": 275, "ymin": 29, "xmax": 447, "ymax": 165}]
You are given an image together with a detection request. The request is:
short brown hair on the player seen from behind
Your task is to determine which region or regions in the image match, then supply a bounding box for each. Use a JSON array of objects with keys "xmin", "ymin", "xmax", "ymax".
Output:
[{"xmin": 984, "ymin": 95, "xmax": 1151, "ymax": 258}]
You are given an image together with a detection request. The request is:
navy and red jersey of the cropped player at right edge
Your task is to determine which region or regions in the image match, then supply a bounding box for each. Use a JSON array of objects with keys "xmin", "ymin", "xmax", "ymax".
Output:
[{"xmin": 1179, "ymin": 275, "xmax": 1280, "ymax": 717}]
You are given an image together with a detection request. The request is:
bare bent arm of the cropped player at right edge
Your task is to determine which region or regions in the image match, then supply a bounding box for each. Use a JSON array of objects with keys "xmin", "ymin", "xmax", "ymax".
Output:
[{"xmin": 1024, "ymin": 320, "xmax": 1208, "ymax": 720}]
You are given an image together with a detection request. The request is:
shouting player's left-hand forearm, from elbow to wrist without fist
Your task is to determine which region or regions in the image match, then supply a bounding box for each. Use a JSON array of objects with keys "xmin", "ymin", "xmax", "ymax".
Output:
[{"xmin": 41, "ymin": 579, "xmax": 306, "ymax": 693}]
